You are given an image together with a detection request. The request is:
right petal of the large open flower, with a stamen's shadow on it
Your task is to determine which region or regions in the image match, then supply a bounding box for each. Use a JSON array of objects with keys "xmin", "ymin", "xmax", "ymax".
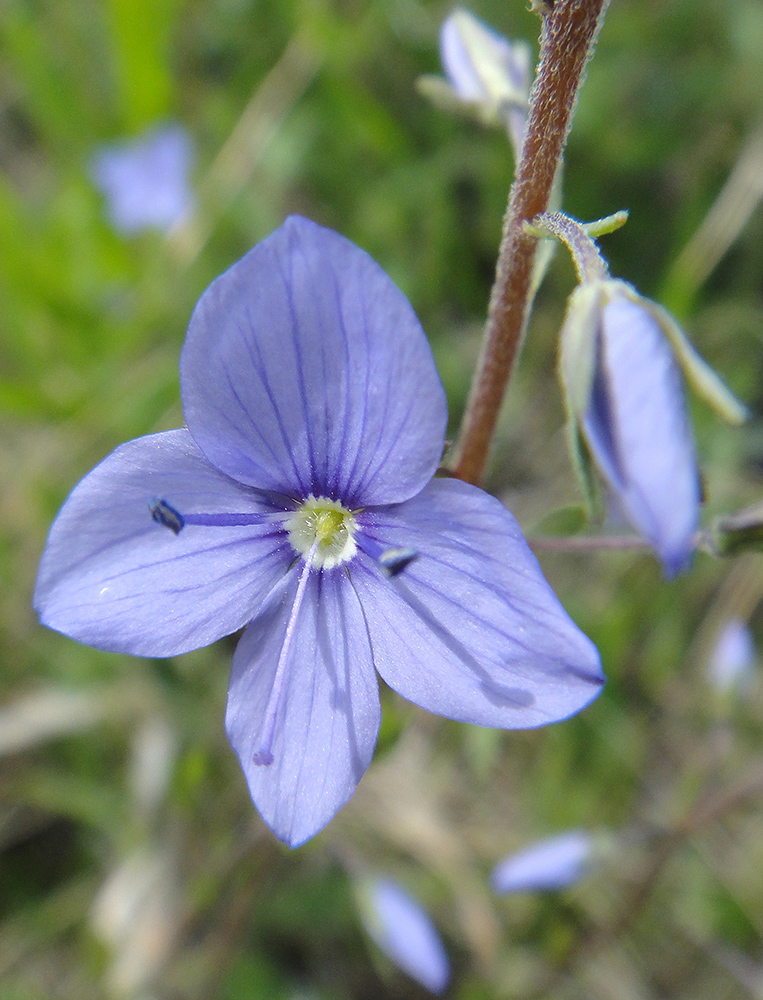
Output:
[{"xmin": 350, "ymin": 479, "xmax": 604, "ymax": 729}]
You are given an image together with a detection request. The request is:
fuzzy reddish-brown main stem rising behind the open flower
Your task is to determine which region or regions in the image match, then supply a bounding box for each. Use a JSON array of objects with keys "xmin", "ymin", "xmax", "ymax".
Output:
[{"xmin": 453, "ymin": 0, "xmax": 609, "ymax": 484}]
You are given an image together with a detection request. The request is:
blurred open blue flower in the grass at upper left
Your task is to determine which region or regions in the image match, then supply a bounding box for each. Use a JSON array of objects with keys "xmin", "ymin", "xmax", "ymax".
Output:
[{"xmin": 91, "ymin": 125, "xmax": 193, "ymax": 236}]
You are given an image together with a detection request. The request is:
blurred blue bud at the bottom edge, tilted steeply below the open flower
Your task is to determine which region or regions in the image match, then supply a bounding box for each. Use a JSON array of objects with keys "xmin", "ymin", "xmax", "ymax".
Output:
[{"xmin": 361, "ymin": 879, "xmax": 450, "ymax": 993}]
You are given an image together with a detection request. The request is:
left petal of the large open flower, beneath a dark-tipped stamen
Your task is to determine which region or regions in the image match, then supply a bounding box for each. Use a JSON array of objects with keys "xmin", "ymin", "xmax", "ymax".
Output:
[{"xmin": 34, "ymin": 430, "xmax": 293, "ymax": 656}]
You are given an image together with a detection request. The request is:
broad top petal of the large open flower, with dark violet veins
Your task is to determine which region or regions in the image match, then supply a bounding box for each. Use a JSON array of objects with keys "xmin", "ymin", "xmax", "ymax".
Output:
[{"xmin": 180, "ymin": 216, "xmax": 446, "ymax": 506}]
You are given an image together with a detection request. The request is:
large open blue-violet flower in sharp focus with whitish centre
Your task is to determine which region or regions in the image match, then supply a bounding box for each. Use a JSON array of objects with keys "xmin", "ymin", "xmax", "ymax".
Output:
[{"xmin": 35, "ymin": 217, "xmax": 603, "ymax": 846}]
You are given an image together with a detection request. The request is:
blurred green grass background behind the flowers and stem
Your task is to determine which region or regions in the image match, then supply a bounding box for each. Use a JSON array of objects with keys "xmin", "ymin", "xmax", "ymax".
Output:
[{"xmin": 0, "ymin": 0, "xmax": 763, "ymax": 1000}]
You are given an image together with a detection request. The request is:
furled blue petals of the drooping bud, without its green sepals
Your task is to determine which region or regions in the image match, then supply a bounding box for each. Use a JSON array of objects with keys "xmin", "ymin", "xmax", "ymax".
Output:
[{"xmin": 583, "ymin": 295, "xmax": 700, "ymax": 576}]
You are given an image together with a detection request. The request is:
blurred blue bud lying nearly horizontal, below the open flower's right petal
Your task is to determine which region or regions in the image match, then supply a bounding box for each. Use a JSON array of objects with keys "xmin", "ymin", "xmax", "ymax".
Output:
[{"xmin": 492, "ymin": 830, "xmax": 594, "ymax": 893}]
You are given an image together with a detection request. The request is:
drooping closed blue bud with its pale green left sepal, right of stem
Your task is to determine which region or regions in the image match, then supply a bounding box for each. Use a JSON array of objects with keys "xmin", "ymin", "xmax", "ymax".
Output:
[{"xmin": 560, "ymin": 278, "xmax": 700, "ymax": 576}]
